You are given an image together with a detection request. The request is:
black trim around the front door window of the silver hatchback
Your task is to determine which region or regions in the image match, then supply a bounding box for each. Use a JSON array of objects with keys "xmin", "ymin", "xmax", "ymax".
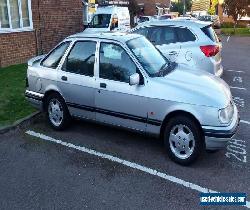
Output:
[{"xmin": 97, "ymin": 40, "xmax": 145, "ymax": 85}]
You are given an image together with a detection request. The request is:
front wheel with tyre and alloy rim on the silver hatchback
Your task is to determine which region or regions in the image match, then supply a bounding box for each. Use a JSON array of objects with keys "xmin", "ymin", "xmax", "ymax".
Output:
[{"xmin": 164, "ymin": 116, "xmax": 205, "ymax": 166}]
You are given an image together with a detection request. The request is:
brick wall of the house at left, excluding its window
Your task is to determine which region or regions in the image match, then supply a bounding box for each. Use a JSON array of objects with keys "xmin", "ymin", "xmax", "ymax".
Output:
[{"xmin": 0, "ymin": 0, "xmax": 83, "ymax": 67}]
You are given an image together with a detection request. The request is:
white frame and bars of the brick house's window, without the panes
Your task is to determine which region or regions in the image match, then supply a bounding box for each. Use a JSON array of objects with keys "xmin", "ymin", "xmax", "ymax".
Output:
[{"xmin": 0, "ymin": 0, "xmax": 33, "ymax": 33}]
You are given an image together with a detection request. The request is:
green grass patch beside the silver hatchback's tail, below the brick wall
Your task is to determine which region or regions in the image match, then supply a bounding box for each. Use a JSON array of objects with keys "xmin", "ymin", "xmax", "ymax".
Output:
[{"xmin": 0, "ymin": 64, "xmax": 35, "ymax": 127}]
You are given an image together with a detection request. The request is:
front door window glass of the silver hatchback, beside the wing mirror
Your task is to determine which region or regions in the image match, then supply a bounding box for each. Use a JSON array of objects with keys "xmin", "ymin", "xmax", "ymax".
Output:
[{"xmin": 99, "ymin": 43, "xmax": 136, "ymax": 83}]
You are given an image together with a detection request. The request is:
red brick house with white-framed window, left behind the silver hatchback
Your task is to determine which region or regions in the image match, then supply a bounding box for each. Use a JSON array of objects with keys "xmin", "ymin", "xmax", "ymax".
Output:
[{"xmin": 0, "ymin": 0, "xmax": 83, "ymax": 67}]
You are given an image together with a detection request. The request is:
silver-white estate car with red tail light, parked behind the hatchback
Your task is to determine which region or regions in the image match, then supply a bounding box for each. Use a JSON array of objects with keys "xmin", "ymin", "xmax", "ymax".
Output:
[{"xmin": 131, "ymin": 19, "xmax": 223, "ymax": 77}]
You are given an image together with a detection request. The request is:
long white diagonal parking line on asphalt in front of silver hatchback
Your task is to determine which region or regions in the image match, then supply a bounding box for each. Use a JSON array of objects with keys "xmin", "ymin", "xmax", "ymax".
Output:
[{"xmin": 26, "ymin": 130, "xmax": 250, "ymax": 208}]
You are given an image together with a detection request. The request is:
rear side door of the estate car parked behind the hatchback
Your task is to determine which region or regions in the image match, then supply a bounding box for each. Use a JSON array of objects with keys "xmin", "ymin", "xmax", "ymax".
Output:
[{"xmin": 149, "ymin": 26, "xmax": 181, "ymax": 62}]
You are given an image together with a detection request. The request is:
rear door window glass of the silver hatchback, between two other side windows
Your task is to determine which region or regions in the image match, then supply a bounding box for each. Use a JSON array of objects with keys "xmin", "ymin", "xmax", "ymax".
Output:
[{"xmin": 62, "ymin": 41, "xmax": 96, "ymax": 77}]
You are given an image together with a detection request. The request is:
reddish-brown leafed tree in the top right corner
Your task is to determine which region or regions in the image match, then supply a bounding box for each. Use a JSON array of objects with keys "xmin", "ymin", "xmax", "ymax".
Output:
[{"xmin": 224, "ymin": 0, "xmax": 250, "ymax": 31}]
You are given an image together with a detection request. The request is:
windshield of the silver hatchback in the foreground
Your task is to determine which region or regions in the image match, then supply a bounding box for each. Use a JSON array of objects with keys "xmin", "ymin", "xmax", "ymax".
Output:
[{"xmin": 127, "ymin": 37, "xmax": 169, "ymax": 77}]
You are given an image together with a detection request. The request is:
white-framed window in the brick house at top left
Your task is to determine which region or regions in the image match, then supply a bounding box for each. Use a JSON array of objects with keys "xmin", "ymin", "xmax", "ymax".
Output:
[{"xmin": 0, "ymin": 0, "xmax": 33, "ymax": 32}]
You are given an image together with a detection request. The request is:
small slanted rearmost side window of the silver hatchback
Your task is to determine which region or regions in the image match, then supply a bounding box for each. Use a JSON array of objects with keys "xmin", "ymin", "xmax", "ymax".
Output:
[{"xmin": 41, "ymin": 42, "xmax": 70, "ymax": 69}]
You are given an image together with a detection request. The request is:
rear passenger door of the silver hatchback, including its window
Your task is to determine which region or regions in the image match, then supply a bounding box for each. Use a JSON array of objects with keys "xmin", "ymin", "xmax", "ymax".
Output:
[{"xmin": 58, "ymin": 40, "xmax": 96, "ymax": 119}]
